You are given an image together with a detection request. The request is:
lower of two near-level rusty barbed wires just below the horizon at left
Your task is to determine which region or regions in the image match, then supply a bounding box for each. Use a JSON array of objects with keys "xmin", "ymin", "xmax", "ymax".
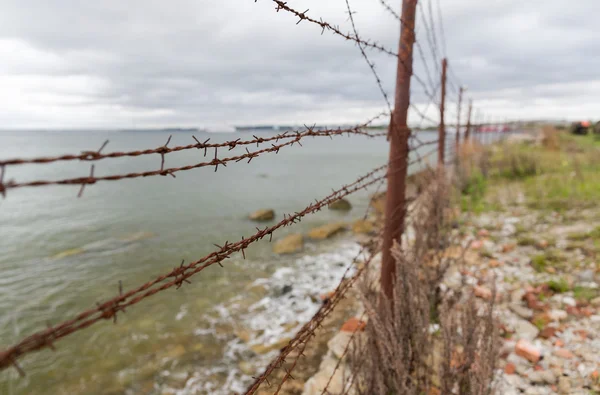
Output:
[{"xmin": 0, "ymin": 126, "xmax": 387, "ymax": 196}]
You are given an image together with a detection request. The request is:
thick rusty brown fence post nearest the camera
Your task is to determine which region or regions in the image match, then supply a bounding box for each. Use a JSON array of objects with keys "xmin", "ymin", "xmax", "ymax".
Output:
[{"xmin": 381, "ymin": 0, "xmax": 418, "ymax": 300}]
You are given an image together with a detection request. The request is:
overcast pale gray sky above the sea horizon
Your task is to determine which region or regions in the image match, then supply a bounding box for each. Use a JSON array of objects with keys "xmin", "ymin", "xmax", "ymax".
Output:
[{"xmin": 0, "ymin": 0, "xmax": 600, "ymax": 128}]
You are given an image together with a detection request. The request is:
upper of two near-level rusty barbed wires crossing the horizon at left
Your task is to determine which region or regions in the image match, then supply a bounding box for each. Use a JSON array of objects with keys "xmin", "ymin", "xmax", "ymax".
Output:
[{"xmin": 0, "ymin": 111, "xmax": 390, "ymax": 168}]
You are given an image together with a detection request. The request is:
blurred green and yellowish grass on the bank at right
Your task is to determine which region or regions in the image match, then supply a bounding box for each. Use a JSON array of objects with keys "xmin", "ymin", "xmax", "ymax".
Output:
[{"xmin": 457, "ymin": 127, "xmax": 600, "ymax": 213}]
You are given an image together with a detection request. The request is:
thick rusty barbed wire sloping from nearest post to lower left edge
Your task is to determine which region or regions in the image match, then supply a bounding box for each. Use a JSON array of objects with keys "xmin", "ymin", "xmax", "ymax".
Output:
[{"xmin": 0, "ymin": 164, "xmax": 387, "ymax": 372}]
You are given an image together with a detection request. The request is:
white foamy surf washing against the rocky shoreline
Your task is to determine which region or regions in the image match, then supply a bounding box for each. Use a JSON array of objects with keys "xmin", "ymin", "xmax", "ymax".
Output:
[{"xmin": 177, "ymin": 241, "xmax": 360, "ymax": 395}]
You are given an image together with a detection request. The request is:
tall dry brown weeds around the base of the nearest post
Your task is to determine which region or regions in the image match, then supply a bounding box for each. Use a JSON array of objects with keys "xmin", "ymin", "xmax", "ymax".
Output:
[{"xmin": 352, "ymin": 172, "xmax": 498, "ymax": 394}]
